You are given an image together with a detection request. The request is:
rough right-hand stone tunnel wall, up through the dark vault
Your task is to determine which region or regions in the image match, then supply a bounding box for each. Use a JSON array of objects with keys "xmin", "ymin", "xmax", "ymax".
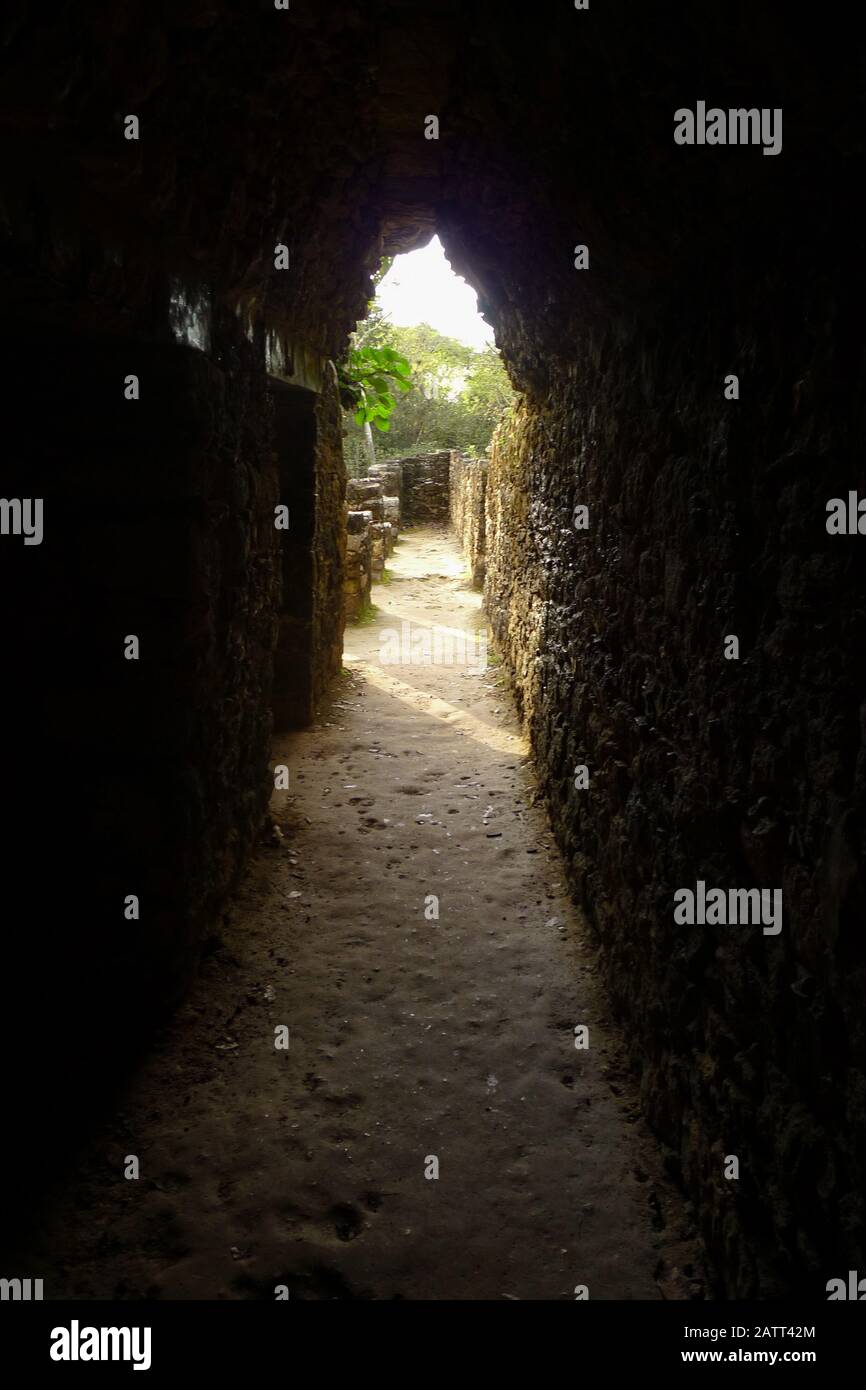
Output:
[{"xmin": 441, "ymin": 4, "xmax": 866, "ymax": 1297}]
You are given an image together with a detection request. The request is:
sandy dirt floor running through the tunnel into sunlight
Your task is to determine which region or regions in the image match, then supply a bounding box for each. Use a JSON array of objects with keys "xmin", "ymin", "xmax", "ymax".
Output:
[{"xmin": 17, "ymin": 528, "xmax": 706, "ymax": 1300}]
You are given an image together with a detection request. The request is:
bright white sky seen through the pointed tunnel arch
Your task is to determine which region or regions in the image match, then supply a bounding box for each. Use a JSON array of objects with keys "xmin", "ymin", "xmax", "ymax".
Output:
[{"xmin": 375, "ymin": 236, "xmax": 493, "ymax": 350}]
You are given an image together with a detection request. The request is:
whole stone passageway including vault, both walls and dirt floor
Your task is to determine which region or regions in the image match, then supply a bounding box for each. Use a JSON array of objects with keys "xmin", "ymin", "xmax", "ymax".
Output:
[{"xmin": 0, "ymin": 0, "xmax": 866, "ymax": 1323}]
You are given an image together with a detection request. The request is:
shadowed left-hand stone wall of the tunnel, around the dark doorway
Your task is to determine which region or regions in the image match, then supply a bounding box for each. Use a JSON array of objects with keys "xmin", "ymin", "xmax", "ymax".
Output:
[{"xmin": 0, "ymin": 0, "xmax": 381, "ymax": 1129}]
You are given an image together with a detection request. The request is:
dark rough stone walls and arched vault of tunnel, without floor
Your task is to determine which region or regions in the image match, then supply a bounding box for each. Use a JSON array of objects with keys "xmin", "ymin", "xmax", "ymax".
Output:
[{"xmin": 0, "ymin": 0, "xmax": 866, "ymax": 1298}]
